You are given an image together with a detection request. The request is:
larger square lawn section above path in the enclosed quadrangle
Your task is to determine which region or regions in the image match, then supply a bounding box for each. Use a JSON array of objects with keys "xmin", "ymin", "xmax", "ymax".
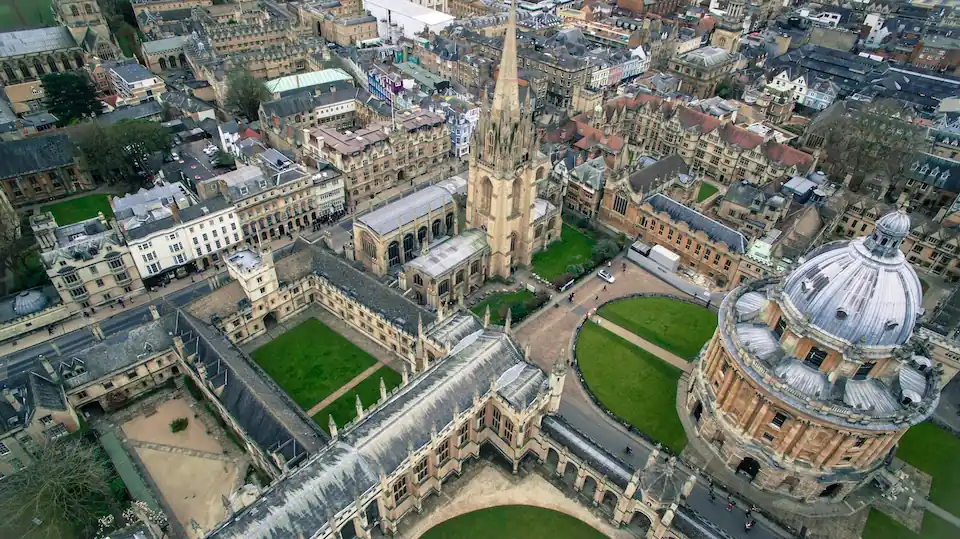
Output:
[{"xmin": 253, "ymin": 318, "xmax": 377, "ymax": 410}]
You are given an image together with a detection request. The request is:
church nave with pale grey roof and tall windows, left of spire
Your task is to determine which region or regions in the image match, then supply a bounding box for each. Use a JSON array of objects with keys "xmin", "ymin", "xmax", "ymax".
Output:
[{"xmin": 353, "ymin": 176, "xmax": 467, "ymax": 276}]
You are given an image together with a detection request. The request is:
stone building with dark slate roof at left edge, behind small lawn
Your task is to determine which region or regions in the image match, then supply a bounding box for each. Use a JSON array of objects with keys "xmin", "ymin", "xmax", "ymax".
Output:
[{"xmin": 0, "ymin": 133, "xmax": 95, "ymax": 206}]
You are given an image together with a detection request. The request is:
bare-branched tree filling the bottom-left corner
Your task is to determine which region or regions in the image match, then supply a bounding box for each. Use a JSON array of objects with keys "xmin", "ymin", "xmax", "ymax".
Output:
[{"xmin": 0, "ymin": 436, "xmax": 124, "ymax": 538}]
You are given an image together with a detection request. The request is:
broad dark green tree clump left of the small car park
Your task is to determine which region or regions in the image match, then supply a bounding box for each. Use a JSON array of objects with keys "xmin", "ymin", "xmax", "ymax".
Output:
[{"xmin": 70, "ymin": 120, "xmax": 170, "ymax": 183}]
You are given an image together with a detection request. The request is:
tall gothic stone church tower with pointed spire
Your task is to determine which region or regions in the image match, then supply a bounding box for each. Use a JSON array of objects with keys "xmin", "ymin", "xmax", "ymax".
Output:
[{"xmin": 467, "ymin": 0, "xmax": 549, "ymax": 277}]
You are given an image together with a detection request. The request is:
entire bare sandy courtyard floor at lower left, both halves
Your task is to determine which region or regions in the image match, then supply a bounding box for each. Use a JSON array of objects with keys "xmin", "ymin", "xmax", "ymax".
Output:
[{"xmin": 121, "ymin": 397, "xmax": 246, "ymax": 537}]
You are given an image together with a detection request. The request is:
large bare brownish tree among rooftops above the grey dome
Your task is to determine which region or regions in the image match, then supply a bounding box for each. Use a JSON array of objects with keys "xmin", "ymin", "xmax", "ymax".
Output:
[{"xmin": 811, "ymin": 101, "xmax": 927, "ymax": 193}]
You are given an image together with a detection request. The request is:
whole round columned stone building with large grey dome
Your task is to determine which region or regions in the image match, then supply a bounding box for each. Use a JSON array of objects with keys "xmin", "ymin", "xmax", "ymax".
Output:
[{"xmin": 683, "ymin": 211, "xmax": 942, "ymax": 502}]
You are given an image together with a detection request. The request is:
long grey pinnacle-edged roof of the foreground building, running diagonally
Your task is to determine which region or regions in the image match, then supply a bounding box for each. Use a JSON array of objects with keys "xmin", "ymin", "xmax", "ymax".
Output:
[{"xmin": 210, "ymin": 324, "xmax": 547, "ymax": 539}]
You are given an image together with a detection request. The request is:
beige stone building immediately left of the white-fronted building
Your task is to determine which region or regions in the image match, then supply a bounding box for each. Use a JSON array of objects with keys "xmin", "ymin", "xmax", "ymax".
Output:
[{"xmin": 30, "ymin": 212, "xmax": 144, "ymax": 313}]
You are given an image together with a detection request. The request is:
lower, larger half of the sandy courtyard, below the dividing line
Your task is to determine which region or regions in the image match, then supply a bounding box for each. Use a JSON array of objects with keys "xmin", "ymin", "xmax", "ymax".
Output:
[{"xmin": 137, "ymin": 447, "xmax": 239, "ymax": 537}]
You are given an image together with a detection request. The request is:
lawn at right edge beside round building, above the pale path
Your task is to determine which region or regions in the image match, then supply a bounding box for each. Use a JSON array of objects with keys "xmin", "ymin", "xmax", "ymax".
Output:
[{"xmin": 897, "ymin": 422, "xmax": 960, "ymax": 516}]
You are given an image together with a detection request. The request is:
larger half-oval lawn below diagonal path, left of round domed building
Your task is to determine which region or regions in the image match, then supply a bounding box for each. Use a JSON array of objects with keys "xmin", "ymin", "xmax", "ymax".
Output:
[{"xmin": 576, "ymin": 322, "xmax": 687, "ymax": 453}]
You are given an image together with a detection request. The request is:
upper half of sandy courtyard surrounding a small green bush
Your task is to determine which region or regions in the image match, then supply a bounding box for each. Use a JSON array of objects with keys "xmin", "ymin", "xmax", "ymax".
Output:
[{"xmin": 123, "ymin": 398, "xmax": 223, "ymax": 453}]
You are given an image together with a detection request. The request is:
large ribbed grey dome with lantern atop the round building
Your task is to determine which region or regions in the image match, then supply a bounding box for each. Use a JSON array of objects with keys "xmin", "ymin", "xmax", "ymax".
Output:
[{"xmin": 783, "ymin": 210, "xmax": 923, "ymax": 348}]
